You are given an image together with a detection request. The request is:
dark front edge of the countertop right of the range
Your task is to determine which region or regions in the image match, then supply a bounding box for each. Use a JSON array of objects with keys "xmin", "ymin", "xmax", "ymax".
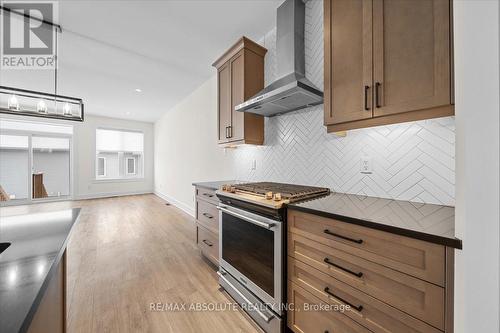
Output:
[{"xmin": 287, "ymin": 204, "xmax": 462, "ymax": 250}]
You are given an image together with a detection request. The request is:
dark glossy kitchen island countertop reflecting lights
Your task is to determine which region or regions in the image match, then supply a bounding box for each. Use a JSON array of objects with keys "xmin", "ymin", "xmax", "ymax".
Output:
[{"xmin": 0, "ymin": 208, "xmax": 80, "ymax": 333}]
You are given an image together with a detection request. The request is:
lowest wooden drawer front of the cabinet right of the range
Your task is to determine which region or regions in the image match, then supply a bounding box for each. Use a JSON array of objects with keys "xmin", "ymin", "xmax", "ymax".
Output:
[{"xmin": 287, "ymin": 282, "xmax": 370, "ymax": 333}]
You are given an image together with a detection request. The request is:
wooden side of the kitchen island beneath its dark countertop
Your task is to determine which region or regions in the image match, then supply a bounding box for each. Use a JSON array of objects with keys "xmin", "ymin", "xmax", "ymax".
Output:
[{"xmin": 28, "ymin": 251, "xmax": 66, "ymax": 333}]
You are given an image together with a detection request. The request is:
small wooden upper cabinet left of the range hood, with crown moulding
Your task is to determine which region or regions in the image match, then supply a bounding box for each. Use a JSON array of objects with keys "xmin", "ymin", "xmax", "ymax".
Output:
[{"xmin": 213, "ymin": 37, "xmax": 267, "ymax": 146}]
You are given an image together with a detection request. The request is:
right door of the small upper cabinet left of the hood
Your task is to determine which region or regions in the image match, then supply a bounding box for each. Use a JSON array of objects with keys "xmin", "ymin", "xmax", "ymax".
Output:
[{"xmin": 229, "ymin": 51, "xmax": 245, "ymax": 141}]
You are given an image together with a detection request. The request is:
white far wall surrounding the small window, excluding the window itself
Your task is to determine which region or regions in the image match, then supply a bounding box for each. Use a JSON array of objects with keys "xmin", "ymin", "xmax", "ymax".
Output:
[{"xmin": 73, "ymin": 116, "xmax": 154, "ymax": 199}]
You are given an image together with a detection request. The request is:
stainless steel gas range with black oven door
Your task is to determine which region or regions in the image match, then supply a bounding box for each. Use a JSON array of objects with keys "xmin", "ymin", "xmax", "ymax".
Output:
[{"xmin": 216, "ymin": 182, "xmax": 330, "ymax": 332}]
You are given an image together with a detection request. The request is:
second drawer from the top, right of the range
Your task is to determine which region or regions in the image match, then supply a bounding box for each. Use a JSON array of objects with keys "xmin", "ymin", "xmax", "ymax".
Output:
[{"xmin": 288, "ymin": 233, "xmax": 444, "ymax": 327}]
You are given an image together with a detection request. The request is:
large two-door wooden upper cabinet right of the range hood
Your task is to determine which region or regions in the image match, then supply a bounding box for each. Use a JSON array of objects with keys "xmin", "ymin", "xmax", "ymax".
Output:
[{"xmin": 324, "ymin": 0, "xmax": 454, "ymax": 132}]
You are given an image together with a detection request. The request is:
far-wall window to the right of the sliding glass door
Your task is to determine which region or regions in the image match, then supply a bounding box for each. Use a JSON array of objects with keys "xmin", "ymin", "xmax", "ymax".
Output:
[{"xmin": 96, "ymin": 129, "xmax": 144, "ymax": 180}]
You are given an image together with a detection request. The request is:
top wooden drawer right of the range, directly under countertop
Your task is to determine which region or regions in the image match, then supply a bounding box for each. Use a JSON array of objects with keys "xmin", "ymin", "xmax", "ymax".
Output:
[{"xmin": 288, "ymin": 210, "xmax": 445, "ymax": 286}]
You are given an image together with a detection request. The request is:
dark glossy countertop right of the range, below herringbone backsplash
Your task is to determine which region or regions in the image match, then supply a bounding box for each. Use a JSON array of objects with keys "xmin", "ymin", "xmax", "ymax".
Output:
[{"xmin": 288, "ymin": 193, "xmax": 462, "ymax": 249}]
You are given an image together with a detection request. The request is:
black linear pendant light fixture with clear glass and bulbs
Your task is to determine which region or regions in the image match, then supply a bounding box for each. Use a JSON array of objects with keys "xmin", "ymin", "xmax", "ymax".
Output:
[{"xmin": 0, "ymin": 5, "xmax": 84, "ymax": 121}]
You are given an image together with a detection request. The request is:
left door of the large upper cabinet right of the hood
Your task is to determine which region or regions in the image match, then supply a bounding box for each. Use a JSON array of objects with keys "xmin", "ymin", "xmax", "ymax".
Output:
[{"xmin": 324, "ymin": 0, "xmax": 373, "ymax": 125}]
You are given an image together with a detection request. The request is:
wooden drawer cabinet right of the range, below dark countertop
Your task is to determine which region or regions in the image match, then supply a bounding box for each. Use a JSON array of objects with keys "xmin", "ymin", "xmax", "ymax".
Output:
[{"xmin": 287, "ymin": 209, "xmax": 454, "ymax": 333}]
